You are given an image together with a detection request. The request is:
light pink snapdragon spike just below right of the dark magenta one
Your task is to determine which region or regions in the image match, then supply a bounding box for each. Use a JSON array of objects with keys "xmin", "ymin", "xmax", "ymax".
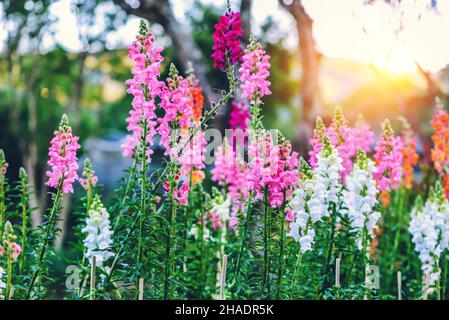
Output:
[{"xmin": 239, "ymin": 37, "xmax": 271, "ymax": 105}]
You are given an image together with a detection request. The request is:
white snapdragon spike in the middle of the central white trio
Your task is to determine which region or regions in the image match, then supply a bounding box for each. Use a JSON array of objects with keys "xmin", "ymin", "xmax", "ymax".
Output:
[{"xmin": 315, "ymin": 137, "xmax": 343, "ymax": 210}]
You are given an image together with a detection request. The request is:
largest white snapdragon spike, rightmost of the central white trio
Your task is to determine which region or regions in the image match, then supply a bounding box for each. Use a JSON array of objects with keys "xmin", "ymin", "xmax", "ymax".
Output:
[{"xmin": 343, "ymin": 151, "xmax": 380, "ymax": 250}]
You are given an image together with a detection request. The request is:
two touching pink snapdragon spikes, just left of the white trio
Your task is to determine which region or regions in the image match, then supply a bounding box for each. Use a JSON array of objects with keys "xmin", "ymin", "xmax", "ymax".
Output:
[{"xmin": 247, "ymin": 132, "xmax": 299, "ymax": 207}]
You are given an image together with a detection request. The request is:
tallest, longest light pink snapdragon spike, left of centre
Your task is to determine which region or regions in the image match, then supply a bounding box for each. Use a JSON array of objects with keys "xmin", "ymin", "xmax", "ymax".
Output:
[{"xmin": 122, "ymin": 28, "xmax": 164, "ymax": 161}]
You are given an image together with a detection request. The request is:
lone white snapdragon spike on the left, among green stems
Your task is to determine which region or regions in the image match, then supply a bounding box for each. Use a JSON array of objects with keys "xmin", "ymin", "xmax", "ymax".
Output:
[{"xmin": 82, "ymin": 196, "xmax": 114, "ymax": 267}]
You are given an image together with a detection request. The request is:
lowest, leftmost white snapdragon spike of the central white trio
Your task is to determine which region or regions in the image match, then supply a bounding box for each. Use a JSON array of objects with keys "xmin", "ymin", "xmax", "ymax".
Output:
[{"xmin": 287, "ymin": 163, "xmax": 328, "ymax": 253}]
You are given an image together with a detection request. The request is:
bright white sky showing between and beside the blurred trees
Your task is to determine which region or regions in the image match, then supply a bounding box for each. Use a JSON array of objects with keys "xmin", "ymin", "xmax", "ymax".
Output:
[{"xmin": 0, "ymin": 0, "xmax": 449, "ymax": 72}]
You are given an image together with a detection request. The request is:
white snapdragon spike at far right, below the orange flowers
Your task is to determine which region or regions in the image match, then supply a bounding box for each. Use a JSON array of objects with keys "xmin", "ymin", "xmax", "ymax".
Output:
[{"xmin": 409, "ymin": 199, "xmax": 442, "ymax": 297}]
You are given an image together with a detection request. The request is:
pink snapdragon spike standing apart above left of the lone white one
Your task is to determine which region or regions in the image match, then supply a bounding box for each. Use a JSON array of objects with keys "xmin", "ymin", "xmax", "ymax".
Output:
[{"xmin": 46, "ymin": 114, "xmax": 80, "ymax": 193}]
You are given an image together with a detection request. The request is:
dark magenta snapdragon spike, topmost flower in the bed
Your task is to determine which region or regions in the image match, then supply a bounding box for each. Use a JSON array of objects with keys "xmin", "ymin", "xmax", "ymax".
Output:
[{"xmin": 211, "ymin": 10, "xmax": 243, "ymax": 70}]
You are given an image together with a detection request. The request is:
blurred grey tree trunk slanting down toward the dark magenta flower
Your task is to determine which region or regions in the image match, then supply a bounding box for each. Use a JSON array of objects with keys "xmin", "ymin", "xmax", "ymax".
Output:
[{"xmin": 113, "ymin": 0, "xmax": 216, "ymax": 105}]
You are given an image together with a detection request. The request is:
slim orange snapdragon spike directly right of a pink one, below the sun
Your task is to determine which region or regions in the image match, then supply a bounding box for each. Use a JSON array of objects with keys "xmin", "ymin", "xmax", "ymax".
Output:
[{"xmin": 399, "ymin": 117, "xmax": 419, "ymax": 189}]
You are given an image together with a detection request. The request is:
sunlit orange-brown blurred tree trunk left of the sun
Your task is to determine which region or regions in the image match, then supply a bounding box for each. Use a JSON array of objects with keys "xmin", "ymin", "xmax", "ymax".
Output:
[{"xmin": 279, "ymin": 0, "xmax": 322, "ymax": 156}]
